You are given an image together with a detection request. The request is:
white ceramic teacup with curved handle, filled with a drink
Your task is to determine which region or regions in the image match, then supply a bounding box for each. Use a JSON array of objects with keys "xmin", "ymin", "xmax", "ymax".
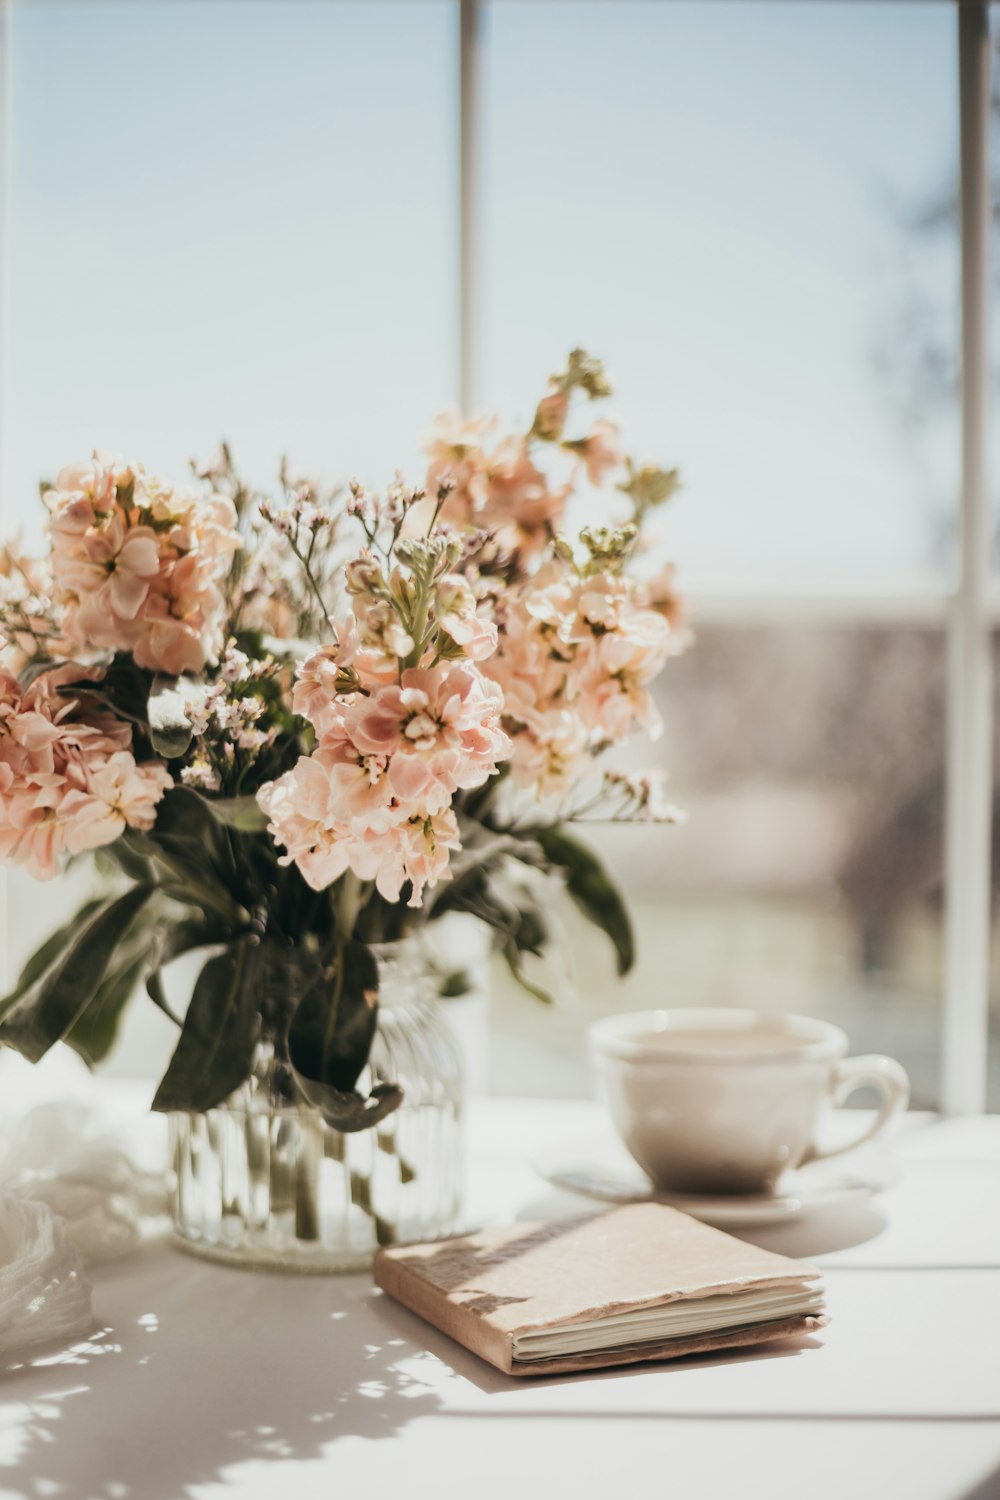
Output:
[{"xmin": 588, "ymin": 1010, "xmax": 910, "ymax": 1193}]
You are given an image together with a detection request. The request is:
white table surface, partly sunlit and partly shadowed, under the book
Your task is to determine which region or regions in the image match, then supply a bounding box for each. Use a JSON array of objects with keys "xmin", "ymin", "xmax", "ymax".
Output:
[{"xmin": 0, "ymin": 1100, "xmax": 1000, "ymax": 1500}]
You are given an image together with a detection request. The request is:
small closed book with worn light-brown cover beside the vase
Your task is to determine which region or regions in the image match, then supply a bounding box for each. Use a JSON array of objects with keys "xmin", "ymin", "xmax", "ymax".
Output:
[{"xmin": 375, "ymin": 1203, "xmax": 826, "ymax": 1376}]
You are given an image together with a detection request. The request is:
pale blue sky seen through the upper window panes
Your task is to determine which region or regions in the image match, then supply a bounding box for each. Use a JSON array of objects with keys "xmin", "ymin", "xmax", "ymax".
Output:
[{"xmin": 3, "ymin": 0, "xmax": 958, "ymax": 588}]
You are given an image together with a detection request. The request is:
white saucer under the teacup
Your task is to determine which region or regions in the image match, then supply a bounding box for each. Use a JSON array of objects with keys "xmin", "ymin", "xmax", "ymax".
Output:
[{"xmin": 534, "ymin": 1134, "xmax": 900, "ymax": 1229}]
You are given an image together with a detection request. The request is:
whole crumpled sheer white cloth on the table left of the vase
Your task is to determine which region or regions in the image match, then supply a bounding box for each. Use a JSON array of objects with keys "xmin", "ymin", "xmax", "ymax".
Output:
[{"xmin": 0, "ymin": 1104, "xmax": 165, "ymax": 1353}]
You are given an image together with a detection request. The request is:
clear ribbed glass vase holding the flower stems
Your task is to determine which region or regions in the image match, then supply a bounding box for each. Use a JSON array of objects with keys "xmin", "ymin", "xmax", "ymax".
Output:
[{"xmin": 169, "ymin": 942, "xmax": 462, "ymax": 1272}]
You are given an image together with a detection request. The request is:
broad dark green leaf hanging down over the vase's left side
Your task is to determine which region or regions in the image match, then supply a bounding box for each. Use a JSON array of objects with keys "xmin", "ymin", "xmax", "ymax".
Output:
[{"xmin": 153, "ymin": 938, "xmax": 262, "ymax": 1112}]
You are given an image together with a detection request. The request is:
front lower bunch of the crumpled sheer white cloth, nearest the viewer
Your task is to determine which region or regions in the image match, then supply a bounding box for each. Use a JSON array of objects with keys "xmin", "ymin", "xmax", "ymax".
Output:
[{"xmin": 0, "ymin": 1193, "xmax": 93, "ymax": 1355}]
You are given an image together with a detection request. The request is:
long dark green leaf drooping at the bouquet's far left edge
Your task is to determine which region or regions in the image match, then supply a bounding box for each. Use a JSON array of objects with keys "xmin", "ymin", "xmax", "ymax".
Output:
[{"xmin": 0, "ymin": 885, "xmax": 153, "ymax": 1062}]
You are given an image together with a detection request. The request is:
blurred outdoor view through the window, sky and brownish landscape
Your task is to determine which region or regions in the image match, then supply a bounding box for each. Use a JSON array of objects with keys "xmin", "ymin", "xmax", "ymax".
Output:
[{"xmin": 1, "ymin": 0, "xmax": 1000, "ymax": 1109}]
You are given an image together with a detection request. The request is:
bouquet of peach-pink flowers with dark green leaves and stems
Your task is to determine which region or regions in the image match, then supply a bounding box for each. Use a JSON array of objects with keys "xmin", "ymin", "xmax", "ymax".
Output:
[{"xmin": 0, "ymin": 350, "xmax": 684, "ymax": 1266}]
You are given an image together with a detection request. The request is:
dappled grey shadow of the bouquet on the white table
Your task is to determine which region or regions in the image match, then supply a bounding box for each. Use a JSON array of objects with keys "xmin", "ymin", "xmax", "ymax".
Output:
[{"xmin": 0, "ymin": 1247, "xmax": 441, "ymax": 1500}]
